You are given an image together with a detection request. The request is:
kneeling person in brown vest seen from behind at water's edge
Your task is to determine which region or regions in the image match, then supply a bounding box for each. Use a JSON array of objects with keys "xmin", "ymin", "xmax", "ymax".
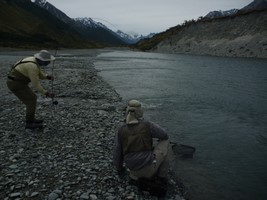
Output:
[{"xmin": 113, "ymin": 100, "xmax": 169, "ymax": 196}]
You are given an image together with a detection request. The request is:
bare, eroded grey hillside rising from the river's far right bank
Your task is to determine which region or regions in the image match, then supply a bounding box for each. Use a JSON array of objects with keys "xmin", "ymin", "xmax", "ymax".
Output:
[{"xmin": 135, "ymin": 9, "xmax": 267, "ymax": 58}]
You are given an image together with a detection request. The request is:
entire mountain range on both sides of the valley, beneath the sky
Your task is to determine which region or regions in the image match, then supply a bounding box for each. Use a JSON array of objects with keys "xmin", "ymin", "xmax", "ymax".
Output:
[{"xmin": 0, "ymin": 0, "xmax": 267, "ymax": 55}]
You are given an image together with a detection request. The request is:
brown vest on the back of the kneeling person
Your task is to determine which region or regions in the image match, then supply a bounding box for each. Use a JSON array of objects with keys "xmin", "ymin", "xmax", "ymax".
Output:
[{"xmin": 118, "ymin": 122, "xmax": 153, "ymax": 155}]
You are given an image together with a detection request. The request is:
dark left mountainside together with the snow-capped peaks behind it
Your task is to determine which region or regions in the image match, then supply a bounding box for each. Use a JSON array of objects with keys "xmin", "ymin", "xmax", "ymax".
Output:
[{"xmin": 0, "ymin": 0, "xmax": 153, "ymax": 48}]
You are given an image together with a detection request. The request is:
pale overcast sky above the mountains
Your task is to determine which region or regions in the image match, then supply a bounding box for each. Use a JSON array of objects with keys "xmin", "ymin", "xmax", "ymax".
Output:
[{"xmin": 47, "ymin": 0, "xmax": 253, "ymax": 35}]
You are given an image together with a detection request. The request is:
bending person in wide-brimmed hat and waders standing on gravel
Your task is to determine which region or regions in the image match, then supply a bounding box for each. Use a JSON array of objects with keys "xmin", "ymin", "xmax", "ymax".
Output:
[{"xmin": 6, "ymin": 50, "xmax": 55, "ymax": 129}]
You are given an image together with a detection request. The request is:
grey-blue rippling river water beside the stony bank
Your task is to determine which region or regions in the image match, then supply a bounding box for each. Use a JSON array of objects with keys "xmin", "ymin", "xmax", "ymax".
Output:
[{"xmin": 95, "ymin": 51, "xmax": 267, "ymax": 200}]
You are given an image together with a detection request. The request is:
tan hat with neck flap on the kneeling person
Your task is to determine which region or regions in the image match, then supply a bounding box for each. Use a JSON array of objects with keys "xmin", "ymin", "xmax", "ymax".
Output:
[{"xmin": 126, "ymin": 99, "xmax": 143, "ymax": 124}]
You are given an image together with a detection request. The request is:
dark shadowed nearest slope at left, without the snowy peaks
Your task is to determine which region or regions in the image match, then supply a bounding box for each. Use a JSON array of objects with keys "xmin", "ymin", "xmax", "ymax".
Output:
[{"xmin": 0, "ymin": 0, "xmax": 104, "ymax": 48}]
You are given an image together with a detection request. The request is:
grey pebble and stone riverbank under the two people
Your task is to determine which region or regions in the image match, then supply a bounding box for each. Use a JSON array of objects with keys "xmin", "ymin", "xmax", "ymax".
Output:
[{"xmin": 0, "ymin": 49, "xmax": 184, "ymax": 200}]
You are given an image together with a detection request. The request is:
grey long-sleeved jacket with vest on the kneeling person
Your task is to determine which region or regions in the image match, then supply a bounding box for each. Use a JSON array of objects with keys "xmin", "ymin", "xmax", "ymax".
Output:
[{"xmin": 113, "ymin": 121, "xmax": 168, "ymax": 170}]
